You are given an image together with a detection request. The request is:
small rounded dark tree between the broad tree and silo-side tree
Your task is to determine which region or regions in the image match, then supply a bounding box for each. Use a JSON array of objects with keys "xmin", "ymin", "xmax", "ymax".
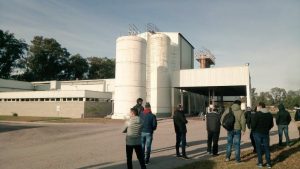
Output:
[{"xmin": 69, "ymin": 54, "xmax": 89, "ymax": 79}]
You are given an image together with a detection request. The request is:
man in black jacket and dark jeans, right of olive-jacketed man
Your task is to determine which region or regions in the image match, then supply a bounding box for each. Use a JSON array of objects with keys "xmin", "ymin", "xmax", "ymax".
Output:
[{"xmin": 251, "ymin": 102, "xmax": 274, "ymax": 168}]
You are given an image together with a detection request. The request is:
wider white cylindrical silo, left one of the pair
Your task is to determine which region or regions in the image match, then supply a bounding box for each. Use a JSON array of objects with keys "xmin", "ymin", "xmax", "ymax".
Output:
[{"xmin": 112, "ymin": 36, "xmax": 147, "ymax": 119}]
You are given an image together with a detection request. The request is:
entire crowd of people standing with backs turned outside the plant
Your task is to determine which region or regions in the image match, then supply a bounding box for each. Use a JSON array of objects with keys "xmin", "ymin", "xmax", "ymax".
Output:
[{"xmin": 124, "ymin": 98, "xmax": 300, "ymax": 169}]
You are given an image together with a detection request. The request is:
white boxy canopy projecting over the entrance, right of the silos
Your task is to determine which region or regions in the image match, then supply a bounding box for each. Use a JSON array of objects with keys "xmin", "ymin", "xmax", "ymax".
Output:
[{"xmin": 172, "ymin": 66, "xmax": 251, "ymax": 106}]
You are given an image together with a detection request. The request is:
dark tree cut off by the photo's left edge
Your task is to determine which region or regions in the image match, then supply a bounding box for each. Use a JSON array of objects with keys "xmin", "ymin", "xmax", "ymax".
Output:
[{"xmin": 0, "ymin": 29, "xmax": 27, "ymax": 78}]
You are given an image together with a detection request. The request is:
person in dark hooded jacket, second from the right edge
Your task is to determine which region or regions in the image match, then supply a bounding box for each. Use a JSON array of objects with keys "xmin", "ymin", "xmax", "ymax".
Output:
[{"xmin": 276, "ymin": 104, "xmax": 292, "ymax": 146}]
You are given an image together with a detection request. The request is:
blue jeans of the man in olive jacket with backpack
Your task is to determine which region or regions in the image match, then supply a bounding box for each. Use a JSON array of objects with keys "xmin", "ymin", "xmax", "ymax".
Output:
[{"xmin": 226, "ymin": 130, "xmax": 241, "ymax": 162}]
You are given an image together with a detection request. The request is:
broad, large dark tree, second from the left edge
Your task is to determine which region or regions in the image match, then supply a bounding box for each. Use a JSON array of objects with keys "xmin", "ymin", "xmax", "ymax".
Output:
[{"xmin": 26, "ymin": 36, "xmax": 70, "ymax": 80}]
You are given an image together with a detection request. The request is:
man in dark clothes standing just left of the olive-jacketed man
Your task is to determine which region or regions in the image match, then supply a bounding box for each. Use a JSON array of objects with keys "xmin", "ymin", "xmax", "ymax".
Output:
[{"xmin": 206, "ymin": 108, "xmax": 221, "ymax": 156}]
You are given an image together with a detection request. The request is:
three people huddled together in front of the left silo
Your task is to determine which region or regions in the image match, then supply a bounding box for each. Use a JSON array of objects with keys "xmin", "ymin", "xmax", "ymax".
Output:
[{"xmin": 123, "ymin": 98, "xmax": 157, "ymax": 169}]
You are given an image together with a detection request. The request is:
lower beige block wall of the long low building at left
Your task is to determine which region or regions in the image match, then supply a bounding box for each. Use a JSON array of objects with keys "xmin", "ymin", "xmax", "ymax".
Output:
[{"xmin": 0, "ymin": 101, "xmax": 112, "ymax": 118}]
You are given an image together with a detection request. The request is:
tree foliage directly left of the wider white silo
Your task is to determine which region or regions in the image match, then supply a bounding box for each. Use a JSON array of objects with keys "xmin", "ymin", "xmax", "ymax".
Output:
[{"xmin": 88, "ymin": 57, "xmax": 115, "ymax": 79}]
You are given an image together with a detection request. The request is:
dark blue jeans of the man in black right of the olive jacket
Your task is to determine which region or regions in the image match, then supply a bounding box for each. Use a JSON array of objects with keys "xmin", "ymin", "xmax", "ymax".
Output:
[{"xmin": 253, "ymin": 132, "xmax": 271, "ymax": 165}]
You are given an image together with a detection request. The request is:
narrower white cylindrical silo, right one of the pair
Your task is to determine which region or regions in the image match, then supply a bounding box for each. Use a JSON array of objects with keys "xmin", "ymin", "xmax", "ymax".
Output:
[{"xmin": 150, "ymin": 33, "xmax": 171, "ymax": 116}]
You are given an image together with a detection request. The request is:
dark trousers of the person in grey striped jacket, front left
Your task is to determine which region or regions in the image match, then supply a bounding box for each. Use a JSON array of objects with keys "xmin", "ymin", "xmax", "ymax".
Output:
[{"xmin": 126, "ymin": 145, "xmax": 146, "ymax": 169}]
